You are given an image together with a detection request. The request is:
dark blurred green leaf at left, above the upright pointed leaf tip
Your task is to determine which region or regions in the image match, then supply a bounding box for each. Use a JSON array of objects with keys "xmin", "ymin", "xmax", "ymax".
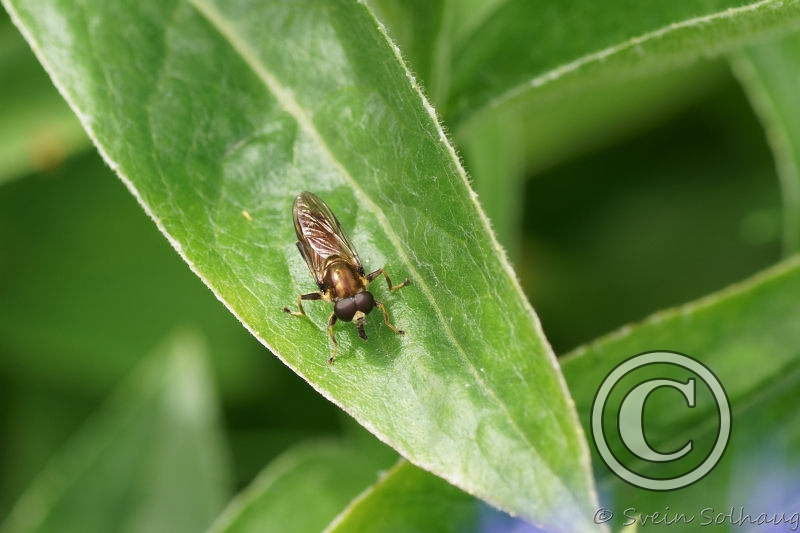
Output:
[{"xmin": 0, "ymin": 153, "xmax": 268, "ymax": 401}]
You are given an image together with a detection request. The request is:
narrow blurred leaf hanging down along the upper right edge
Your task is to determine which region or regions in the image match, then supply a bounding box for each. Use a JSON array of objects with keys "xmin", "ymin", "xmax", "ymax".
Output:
[{"xmin": 732, "ymin": 30, "xmax": 800, "ymax": 255}]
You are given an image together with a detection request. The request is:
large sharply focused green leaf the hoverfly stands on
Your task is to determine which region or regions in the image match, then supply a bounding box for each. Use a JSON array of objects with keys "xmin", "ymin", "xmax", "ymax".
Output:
[{"xmin": 4, "ymin": 0, "xmax": 595, "ymax": 531}]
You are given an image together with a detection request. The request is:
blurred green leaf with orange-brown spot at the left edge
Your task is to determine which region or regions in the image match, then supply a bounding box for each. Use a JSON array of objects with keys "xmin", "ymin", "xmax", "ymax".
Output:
[{"xmin": 0, "ymin": 12, "xmax": 90, "ymax": 183}]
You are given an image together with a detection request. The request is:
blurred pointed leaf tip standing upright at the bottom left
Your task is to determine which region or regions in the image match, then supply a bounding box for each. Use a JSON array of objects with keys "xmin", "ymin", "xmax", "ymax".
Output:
[{"xmin": 2, "ymin": 333, "xmax": 230, "ymax": 533}]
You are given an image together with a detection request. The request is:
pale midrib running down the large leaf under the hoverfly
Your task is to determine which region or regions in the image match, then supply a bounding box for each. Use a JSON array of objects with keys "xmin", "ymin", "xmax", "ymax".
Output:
[{"xmin": 187, "ymin": 0, "xmax": 588, "ymax": 509}]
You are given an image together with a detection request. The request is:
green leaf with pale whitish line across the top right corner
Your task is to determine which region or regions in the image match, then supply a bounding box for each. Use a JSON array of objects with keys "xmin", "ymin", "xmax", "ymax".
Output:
[{"xmin": 444, "ymin": 0, "xmax": 800, "ymax": 122}]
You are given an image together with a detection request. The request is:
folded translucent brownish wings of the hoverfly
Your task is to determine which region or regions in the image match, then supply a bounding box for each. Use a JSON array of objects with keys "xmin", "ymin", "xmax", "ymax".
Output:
[{"xmin": 292, "ymin": 192, "xmax": 361, "ymax": 286}]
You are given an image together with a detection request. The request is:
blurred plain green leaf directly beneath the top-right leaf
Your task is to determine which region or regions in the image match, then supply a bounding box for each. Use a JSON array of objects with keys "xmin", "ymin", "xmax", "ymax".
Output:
[{"xmin": 456, "ymin": 62, "xmax": 727, "ymax": 252}]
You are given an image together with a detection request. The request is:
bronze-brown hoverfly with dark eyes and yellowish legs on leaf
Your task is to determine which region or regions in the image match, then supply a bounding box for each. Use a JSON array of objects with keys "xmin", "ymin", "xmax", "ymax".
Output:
[{"xmin": 283, "ymin": 191, "xmax": 411, "ymax": 364}]
